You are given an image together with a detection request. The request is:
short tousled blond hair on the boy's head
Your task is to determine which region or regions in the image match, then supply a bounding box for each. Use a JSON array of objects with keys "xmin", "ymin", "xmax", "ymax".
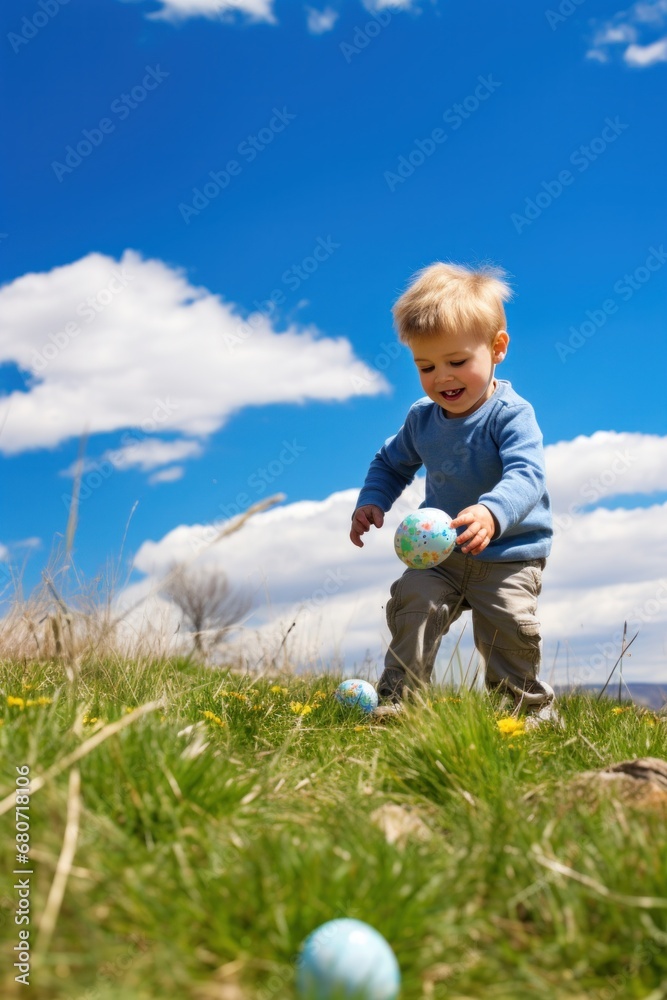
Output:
[{"xmin": 392, "ymin": 262, "xmax": 512, "ymax": 344}]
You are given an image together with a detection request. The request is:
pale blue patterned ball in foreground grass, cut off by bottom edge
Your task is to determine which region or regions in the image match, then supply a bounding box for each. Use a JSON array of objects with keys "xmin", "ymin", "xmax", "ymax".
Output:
[{"xmin": 296, "ymin": 917, "xmax": 401, "ymax": 1000}]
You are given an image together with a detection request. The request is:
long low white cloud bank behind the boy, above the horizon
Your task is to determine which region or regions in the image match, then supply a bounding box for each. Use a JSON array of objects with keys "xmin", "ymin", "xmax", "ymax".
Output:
[{"xmin": 124, "ymin": 432, "xmax": 667, "ymax": 683}]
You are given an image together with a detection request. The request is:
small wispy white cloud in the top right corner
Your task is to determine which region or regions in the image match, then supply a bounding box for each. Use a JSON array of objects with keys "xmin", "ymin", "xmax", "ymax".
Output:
[{"xmin": 586, "ymin": 0, "xmax": 667, "ymax": 69}]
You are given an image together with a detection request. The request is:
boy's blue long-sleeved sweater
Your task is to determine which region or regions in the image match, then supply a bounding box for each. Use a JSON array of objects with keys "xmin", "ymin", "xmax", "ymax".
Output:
[{"xmin": 357, "ymin": 379, "xmax": 553, "ymax": 562}]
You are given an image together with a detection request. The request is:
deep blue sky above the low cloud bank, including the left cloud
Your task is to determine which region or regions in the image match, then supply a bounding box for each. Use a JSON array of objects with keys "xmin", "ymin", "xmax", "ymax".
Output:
[{"xmin": 0, "ymin": 0, "xmax": 667, "ymax": 680}]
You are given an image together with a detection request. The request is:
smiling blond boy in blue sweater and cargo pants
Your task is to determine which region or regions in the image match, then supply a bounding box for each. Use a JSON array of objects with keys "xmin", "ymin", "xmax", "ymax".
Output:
[{"xmin": 350, "ymin": 263, "xmax": 560, "ymax": 725}]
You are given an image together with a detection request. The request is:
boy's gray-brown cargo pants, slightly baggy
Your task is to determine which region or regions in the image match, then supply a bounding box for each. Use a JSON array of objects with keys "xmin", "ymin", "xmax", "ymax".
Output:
[{"xmin": 378, "ymin": 549, "xmax": 553, "ymax": 703}]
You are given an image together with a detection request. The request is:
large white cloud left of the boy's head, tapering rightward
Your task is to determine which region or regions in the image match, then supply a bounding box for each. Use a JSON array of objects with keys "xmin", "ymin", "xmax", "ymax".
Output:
[{"xmin": 0, "ymin": 250, "xmax": 388, "ymax": 454}]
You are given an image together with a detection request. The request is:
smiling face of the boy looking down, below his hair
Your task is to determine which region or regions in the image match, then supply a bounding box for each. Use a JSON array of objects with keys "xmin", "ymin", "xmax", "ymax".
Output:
[{"xmin": 409, "ymin": 330, "xmax": 509, "ymax": 417}]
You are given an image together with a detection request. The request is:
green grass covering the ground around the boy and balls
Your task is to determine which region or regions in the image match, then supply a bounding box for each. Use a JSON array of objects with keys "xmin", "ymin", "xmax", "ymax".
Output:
[{"xmin": 0, "ymin": 661, "xmax": 667, "ymax": 1000}]
